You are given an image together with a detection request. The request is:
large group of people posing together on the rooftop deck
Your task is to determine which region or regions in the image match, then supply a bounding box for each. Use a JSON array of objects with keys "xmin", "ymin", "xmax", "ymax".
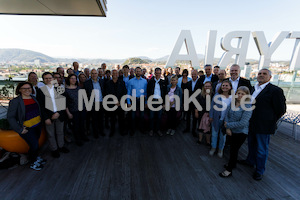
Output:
[{"xmin": 7, "ymin": 62, "xmax": 286, "ymax": 183}]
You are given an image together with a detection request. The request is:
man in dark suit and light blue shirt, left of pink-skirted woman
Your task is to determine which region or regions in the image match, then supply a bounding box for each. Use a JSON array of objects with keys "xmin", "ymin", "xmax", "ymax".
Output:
[{"xmin": 183, "ymin": 70, "xmax": 203, "ymax": 137}]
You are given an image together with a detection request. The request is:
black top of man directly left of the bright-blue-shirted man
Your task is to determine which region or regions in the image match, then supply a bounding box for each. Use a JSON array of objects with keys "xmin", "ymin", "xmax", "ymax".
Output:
[{"xmin": 105, "ymin": 79, "xmax": 127, "ymax": 102}]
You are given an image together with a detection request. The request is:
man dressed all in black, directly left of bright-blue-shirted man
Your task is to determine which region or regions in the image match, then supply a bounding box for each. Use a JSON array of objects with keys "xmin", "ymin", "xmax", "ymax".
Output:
[{"xmin": 105, "ymin": 69, "xmax": 127, "ymax": 137}]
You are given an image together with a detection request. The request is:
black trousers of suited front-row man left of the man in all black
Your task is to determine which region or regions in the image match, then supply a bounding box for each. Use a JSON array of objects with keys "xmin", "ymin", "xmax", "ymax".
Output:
[{"xmin": 91, "ymin": 103, "xmax": 104, "ymax": 137}]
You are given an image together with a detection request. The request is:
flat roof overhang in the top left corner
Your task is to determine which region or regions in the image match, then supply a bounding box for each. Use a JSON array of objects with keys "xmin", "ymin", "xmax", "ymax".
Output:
[{"xmin": 0, "ymin": 0, "xmax": 107, "ymax": 17}]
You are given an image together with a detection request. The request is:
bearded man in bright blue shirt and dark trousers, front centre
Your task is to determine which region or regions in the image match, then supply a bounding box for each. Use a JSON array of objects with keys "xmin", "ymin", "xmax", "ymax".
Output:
[{"xmin": 127, "ymin": 67, "xmax": 147, "ymax": 135}]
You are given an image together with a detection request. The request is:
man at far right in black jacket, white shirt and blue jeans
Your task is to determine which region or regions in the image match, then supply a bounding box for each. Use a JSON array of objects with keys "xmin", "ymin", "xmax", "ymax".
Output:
[{"xmin": 240, "ymin": 69, "xmax": 286, "ymax": 180}]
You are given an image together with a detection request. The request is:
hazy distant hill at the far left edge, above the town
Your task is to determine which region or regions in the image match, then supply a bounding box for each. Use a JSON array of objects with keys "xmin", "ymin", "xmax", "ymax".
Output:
[{"xmin": 0, "ymin": 49, "xmax": 55, "ymax": 62}]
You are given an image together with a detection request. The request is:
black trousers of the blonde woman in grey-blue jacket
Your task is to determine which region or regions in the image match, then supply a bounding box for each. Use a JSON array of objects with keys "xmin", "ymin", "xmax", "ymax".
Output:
[{"xmin": 226, "ymin": 133, "xmax": 247, "ymax": 172}]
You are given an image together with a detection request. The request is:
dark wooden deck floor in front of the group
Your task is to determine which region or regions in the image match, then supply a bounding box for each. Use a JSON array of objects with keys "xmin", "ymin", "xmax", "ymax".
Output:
[{"xmin": 0, "ymin": 122, "xmax": 300, "ymax": 200}]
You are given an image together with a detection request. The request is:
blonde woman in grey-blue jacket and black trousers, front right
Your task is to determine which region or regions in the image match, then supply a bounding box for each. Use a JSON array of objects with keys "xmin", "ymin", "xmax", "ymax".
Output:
[{"xmin": 219, "ymin": 86, "xmax": 252, "ymax": 177}]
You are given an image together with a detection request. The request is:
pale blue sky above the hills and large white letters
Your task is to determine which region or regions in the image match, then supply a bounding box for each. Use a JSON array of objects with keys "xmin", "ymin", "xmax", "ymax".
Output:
[{"xmin": 0, "ymin": 0, "xmax": 300, "ymax": 60}]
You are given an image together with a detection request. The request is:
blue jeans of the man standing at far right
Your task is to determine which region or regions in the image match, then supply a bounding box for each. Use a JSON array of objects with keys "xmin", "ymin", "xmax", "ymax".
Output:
[{"xmin": 247, "ymin": 133, "xmax": 270, "ymax": 174}]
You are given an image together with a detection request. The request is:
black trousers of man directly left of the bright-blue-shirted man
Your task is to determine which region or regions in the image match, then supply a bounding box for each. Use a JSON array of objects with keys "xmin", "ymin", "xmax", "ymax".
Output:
[{"xmin": 107, "ymin": 106, "xmax": 125, "ymax": 134}]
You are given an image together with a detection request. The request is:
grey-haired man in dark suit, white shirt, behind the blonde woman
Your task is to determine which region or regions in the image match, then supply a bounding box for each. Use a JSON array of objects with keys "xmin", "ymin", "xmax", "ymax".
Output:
[{"xmin": 229, "ymin": 64, "xmax": 252, "ymax": 92}]
